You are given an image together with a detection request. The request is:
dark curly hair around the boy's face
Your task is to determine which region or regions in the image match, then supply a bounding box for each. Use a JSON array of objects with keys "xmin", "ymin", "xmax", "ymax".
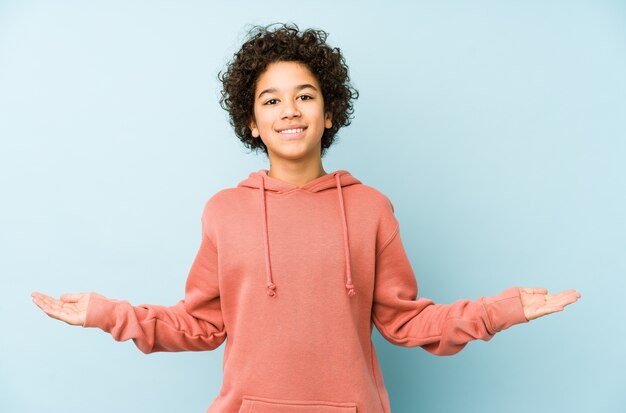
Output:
[{"xmin": 218, "ymin": 23, "xmax": 359, "ymax": 157}]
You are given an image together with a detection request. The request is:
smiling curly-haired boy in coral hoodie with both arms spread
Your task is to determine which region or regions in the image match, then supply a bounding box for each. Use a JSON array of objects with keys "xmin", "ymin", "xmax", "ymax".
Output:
[{"xmin": 33, "ymin": 25, "xmax": 580, "ymax": 413}]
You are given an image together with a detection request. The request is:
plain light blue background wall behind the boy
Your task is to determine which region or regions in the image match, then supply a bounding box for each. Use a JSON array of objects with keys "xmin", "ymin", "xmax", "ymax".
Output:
[{"xmin": 0, "ymin": 0, "xmax": 626, "ymax": 413}]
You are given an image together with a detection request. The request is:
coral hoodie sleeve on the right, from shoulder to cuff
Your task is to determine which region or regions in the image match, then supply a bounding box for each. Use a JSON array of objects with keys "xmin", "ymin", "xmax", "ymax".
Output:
[{"xmin": 372, "ymin": 202, "xmax": 528, "ymax": 356}]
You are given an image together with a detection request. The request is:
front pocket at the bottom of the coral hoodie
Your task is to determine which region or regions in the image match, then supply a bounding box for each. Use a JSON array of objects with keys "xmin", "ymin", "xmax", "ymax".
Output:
[{"xmin": 239, "ymin": 396, "xmax": 356, "ymax": 413}]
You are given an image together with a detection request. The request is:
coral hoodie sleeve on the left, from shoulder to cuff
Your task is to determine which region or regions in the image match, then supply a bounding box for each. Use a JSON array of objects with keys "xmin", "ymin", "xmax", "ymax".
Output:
[{"xmin": 83, "ymin": 204, "xmax": 226, "ymax": 354}]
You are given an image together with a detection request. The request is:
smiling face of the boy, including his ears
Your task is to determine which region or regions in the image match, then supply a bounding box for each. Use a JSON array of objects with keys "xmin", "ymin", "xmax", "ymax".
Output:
[{"xmin": 250, "ymin": 62, "xmax": 332, "ymax": 162}]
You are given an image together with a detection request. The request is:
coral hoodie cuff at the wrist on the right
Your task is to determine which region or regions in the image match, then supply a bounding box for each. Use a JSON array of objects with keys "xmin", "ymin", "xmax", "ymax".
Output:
[{"xmin": 483, "ymin": 287, "xmax": 528, "ymax": 334}]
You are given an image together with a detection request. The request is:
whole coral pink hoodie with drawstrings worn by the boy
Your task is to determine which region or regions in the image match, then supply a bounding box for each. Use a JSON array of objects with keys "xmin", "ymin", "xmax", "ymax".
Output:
[{"xmin": 85, "ymin": 169, "xmax": 528, "ymax": 413}]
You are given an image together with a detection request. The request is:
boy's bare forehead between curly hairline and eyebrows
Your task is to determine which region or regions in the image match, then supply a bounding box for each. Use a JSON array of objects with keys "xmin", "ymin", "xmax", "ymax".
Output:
[{"xmin": 256, "ymin": 62, "xmax": 319, "ymax": 94}]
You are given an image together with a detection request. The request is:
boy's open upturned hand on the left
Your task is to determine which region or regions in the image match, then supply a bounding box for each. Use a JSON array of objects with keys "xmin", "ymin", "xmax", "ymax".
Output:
[{"xmin": 31, "ymin": 292, "xmax": 91, "ymax": 326}]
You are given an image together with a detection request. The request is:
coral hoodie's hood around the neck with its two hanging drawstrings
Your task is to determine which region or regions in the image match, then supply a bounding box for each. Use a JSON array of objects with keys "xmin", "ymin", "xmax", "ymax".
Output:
[{"xmin": 237, "ymin": 169, "xmax": 361, "ymax": 297}]
